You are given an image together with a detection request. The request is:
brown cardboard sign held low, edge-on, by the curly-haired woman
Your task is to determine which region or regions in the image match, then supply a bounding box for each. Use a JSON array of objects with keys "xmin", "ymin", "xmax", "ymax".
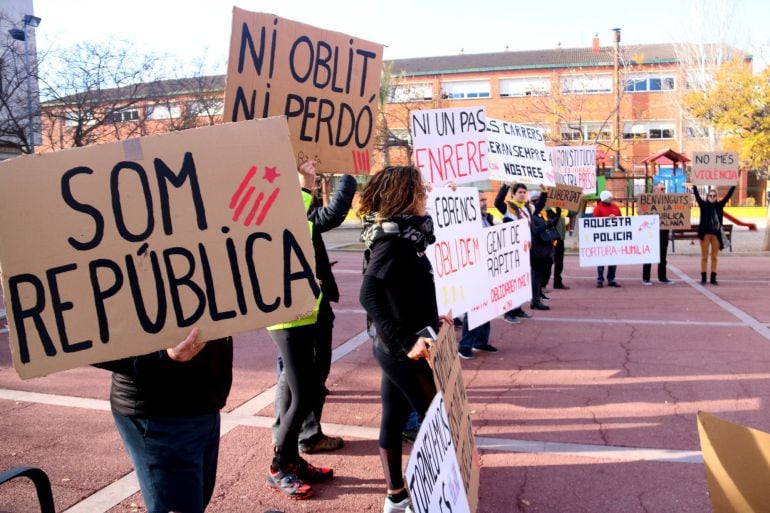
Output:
[{"xmin": 430, "ymin": 324, "xmax": 480, "ymax": 513}]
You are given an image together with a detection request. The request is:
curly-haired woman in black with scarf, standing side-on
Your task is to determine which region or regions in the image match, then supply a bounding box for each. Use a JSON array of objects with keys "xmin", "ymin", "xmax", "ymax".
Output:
[{"xmin": 359, "ymin": 166, "xmax": 452, "ymax": 513}]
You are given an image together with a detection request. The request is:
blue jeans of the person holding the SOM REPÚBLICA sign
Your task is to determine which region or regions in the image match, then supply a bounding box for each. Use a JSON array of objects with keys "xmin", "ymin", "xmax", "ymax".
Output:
[{"xmin": 113, "ymin": 413, "xmax": 220, "ymax": 513}]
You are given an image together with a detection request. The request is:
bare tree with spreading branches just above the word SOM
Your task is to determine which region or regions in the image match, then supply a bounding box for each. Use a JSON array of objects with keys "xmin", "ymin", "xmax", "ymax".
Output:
[{"xmin": 41, "ymin": 41, "xmax": 161, "ymax": 149}]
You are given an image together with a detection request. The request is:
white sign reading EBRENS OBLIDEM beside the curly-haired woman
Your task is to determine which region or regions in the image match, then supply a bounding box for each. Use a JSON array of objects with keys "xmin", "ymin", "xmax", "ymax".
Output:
[{"xmin": 427, "ymin": 187, "xmax": 487, "ymax": 314}]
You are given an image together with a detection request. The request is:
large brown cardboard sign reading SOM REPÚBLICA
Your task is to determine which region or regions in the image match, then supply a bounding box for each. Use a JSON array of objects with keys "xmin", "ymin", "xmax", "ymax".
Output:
[{"xmin": 0, "ymin": 118, "xmax": 320, "ymax": 378}]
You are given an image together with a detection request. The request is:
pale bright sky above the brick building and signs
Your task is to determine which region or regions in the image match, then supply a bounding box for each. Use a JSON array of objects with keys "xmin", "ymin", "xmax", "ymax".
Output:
[{"xmin": 30, "ymin": 0, "xmax": 770, "ymax": 72}]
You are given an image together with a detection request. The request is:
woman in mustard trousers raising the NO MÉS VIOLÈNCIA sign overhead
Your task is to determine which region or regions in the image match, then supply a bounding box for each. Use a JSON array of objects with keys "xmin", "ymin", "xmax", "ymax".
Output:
[{"xmin": 692, "ymin": 185, "xmax": 735, "ymax": 285}]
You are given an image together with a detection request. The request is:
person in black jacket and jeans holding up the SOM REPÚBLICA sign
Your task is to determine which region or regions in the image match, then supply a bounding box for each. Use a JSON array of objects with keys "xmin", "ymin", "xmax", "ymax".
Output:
[{"xmin": 96, "ymin": 328, "xmax": 233, "ymax": 513}]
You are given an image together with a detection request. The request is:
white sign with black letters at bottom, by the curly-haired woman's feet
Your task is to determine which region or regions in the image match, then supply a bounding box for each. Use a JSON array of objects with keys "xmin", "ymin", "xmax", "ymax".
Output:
[{"xmin": 406, "ymin": 392, "xmax": 470, "ymax": 513}]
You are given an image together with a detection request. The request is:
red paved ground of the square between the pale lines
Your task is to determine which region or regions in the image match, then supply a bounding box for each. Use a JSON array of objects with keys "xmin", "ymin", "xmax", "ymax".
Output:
[{"xmin": 0, "ymin": 252, "xmax": 770, "ymax": 513}]
